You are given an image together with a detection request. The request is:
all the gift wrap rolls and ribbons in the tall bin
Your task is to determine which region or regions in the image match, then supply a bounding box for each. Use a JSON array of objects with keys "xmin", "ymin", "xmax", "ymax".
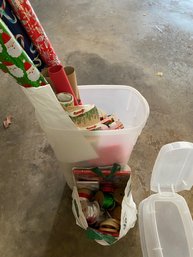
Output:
[{"xmin": 0, "ymin": 0, "xmax": 123, "ymax": 131}]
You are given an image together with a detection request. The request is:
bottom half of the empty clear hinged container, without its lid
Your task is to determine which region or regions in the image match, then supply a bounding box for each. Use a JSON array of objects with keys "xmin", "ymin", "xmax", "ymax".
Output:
[{"xmin": 139, "ymin": 193, "xmax": 193, "ymax": 257}]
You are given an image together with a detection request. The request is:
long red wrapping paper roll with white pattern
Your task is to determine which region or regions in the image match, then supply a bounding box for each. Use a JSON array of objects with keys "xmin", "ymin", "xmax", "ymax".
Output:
[{"xmin": 8, "ymin": 0, "xmax": 60, "ymax": 66}]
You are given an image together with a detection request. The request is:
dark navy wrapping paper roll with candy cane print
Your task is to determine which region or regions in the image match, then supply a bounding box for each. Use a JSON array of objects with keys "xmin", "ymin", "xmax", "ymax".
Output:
[{"xmin": 0, "ymin": 0, "xmax": 45, "ymax": 71}]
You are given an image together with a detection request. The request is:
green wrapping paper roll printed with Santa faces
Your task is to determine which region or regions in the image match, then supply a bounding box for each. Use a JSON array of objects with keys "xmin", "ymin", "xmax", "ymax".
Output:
[{"xmin": 0, "ymin": 19, "xmax": 47, "ymax": 87}]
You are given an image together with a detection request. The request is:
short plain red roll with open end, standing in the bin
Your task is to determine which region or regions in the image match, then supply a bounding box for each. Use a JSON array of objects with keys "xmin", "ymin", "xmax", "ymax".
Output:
[{"xmin": 48, "ymin": 65, "xmax": 78, "ymax": 105}]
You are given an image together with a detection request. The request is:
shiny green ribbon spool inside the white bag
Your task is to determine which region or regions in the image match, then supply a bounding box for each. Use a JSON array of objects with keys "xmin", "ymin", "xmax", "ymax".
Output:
[{"xmin": 95, "ymin": 191, "xmax": 115, "ymax": 209}]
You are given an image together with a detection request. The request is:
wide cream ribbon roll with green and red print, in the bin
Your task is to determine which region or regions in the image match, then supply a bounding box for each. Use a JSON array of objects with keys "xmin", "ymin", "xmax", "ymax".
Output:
[{"xmin": 68, "ymin": 104, "xmax": 100, "ymax": 128}]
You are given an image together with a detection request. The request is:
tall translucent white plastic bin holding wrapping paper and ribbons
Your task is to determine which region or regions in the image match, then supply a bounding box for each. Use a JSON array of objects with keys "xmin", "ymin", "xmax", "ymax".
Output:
[{"xmin": 23, "ymin": 85, "xmax": 149, "ymax": 188}]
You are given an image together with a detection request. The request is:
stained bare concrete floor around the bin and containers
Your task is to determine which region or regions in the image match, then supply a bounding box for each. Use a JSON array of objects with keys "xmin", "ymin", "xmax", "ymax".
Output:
[{"xmin": 0, "ymin": 0, "xmax": 193, "ymax": 257}]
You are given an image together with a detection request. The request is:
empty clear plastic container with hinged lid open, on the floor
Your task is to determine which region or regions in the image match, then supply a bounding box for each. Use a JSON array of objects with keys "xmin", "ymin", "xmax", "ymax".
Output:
[{"xmin": 139, "ymin": 142, "xmax": 193, "ymax": 257}]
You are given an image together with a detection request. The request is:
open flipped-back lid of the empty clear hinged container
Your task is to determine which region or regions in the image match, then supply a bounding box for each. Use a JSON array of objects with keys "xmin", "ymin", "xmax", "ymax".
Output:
[{"xmin": 151, "ymin": 141, "xmax": 193, "ymax": 192}]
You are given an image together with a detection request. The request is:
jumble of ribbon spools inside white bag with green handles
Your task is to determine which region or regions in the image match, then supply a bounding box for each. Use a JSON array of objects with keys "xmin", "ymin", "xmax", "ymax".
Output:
[{"xmin": 72, "ymin": 163, "xmax": 131, "ymax": 237}]
